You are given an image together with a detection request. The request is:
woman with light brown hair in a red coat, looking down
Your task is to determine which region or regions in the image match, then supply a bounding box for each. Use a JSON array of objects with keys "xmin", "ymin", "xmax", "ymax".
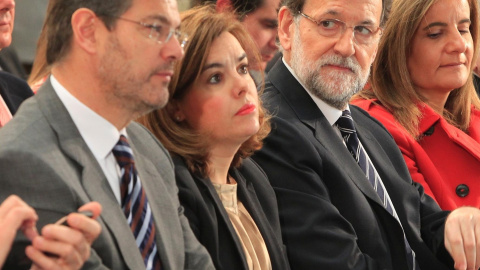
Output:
[{"xmin": 352, "ymin": 0, "xmax": 480, "ymax": 210}]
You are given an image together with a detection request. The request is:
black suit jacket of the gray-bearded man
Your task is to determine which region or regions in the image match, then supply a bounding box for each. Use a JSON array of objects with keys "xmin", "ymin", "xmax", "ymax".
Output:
[{"xmin": 253, "ymin": 60, "xmax": 453, "ymax": 270}]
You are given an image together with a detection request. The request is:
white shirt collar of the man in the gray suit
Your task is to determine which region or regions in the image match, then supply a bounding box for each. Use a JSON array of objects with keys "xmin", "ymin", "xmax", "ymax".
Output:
[{"xmin": 50, "ymin": 75, "xmax": 126, "ymax": 159}]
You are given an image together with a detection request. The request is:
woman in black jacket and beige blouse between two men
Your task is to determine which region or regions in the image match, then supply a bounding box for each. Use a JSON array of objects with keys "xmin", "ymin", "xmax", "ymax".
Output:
[{"xmin": 139, "ymin": 6, "xmax": 289, "ymax": 270}]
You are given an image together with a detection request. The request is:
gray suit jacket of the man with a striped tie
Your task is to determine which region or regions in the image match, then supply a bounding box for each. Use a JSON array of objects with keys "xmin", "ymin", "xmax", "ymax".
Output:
[{"xmin": 0, "ymin": 81, "xmax": 213, "ymax": 270}]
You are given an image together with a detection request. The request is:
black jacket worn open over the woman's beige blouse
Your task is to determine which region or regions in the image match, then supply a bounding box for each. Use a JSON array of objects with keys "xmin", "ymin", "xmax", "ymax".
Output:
[{"xmin": 173, "ymin": 157, "xmax": 289, "ymax": 270}]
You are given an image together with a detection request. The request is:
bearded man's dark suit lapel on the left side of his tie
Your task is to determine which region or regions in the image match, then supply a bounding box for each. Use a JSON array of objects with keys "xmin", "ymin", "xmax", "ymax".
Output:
[{"xmin": 269, "ymin": 61, "xmax": 383, "ymax": 207}]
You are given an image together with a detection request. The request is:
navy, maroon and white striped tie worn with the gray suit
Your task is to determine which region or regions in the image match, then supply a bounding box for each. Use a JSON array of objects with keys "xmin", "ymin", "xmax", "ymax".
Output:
[{"xmin": 112, "ymin": 135, "xmax": 160, "ymax": 270}]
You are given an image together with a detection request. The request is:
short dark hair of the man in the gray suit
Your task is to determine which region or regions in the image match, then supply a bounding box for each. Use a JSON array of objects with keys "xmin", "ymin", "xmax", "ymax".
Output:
[{"xmin": 44, "ymin": 0, "xmax": 133, "ymax": 65}]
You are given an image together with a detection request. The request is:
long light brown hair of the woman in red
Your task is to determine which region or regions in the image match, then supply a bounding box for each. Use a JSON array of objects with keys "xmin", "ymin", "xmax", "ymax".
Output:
[{"xmin": 354, "ymin": 0, "xmax": 480, "ymax": 139}]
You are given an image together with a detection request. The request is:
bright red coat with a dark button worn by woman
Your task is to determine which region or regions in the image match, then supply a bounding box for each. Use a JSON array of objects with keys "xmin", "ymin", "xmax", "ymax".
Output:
[{"xmin": 352, "ymin": 100, "xmax": 480, "ymax": 210}]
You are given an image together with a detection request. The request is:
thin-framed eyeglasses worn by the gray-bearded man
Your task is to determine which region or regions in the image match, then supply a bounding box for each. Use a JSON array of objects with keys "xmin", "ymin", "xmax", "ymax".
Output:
[{"xmin": 298, "ymin": 11, "xmax": 383, "ymax": 45}]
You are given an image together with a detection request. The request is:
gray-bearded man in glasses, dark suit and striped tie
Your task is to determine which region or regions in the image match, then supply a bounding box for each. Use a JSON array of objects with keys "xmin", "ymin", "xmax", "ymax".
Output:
[{"xmin": 254, "ymin": 0, "xmax": 480, "ymax": 270}]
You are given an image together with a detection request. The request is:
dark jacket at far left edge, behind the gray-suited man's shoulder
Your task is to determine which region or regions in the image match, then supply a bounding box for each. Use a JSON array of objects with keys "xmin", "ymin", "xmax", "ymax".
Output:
[{"xmin": 0, "ymin": 71, "xmax": 33, "ymax": 115}]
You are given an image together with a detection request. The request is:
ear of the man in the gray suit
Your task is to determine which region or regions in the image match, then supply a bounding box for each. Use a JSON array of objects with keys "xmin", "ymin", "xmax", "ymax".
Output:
[{"xmin": 72, "ymin": 8, "xmax": 103, "ymax": 54}]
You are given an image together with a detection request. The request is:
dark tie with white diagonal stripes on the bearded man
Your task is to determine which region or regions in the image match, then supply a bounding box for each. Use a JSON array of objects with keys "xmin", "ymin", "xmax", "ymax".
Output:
[{"xmin": 336, "ymin": 110, "xmax": 420, "ymax": 270}]
